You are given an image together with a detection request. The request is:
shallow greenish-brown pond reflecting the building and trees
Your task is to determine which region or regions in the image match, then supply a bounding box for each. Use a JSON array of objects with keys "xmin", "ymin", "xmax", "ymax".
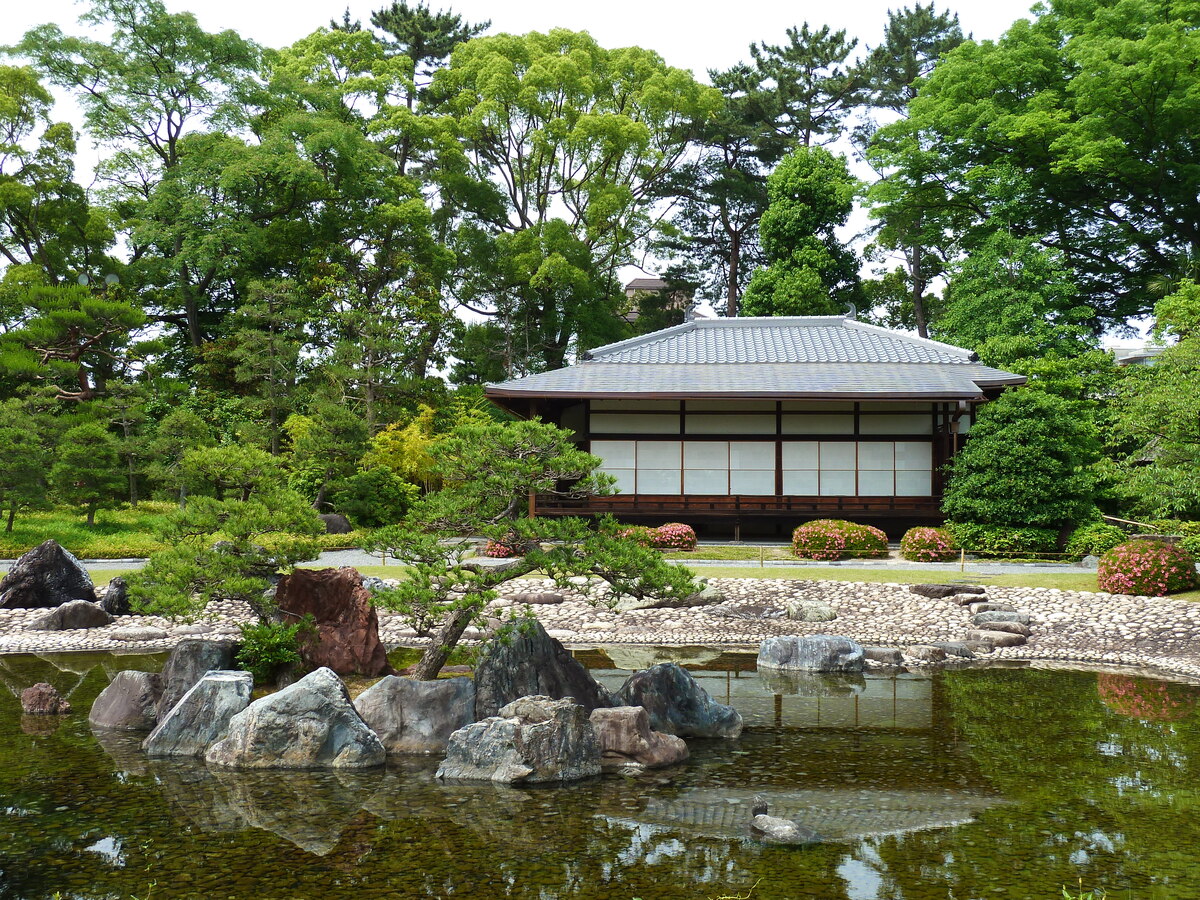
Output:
[{"xmin": 0, "ymin": 648, "xmax": 1200, "ymax": 900}]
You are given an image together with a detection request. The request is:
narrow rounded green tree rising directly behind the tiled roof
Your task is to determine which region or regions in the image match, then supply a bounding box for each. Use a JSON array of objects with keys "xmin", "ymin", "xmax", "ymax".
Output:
[{"xmin": 742, "ymin": 146, "xmax": 860, "ymax": 316}]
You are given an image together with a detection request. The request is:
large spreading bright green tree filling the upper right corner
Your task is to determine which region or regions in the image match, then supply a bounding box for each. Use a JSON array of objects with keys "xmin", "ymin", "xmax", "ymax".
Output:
[{"xmin": 872, "ymin": 0, "xmax": 1200, "ymax": 329}]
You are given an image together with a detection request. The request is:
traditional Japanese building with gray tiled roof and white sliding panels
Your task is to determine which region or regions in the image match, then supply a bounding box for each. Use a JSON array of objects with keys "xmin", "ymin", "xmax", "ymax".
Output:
[{"xmin": 487, "ymin": 316, "xmax": 1026, "ymax": 532}]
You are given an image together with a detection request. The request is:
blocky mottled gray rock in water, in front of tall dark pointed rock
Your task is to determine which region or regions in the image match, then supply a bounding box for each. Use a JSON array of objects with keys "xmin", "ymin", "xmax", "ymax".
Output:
[{"xmin": 437, "ymin": 697, "xmax": 600, "ymax": 784}]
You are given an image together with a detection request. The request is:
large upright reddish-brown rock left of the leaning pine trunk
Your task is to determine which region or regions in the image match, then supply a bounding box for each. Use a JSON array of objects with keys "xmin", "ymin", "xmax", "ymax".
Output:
[{"xmin": 275, "ymin": 566, "xmax": 391, "ymax": 676}]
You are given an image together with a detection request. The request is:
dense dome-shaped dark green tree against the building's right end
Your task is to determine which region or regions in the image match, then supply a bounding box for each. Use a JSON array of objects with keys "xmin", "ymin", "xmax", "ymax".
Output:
[{"xmin": 942, "ymin": 390, "xmax": 1099, "ymax": 532}]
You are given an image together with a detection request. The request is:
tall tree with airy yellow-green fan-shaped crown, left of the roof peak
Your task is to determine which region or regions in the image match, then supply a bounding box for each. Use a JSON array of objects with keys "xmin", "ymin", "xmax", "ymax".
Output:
[{"xmin": 431, "ymin": 30, "xmax": 720, "ymax": 371}]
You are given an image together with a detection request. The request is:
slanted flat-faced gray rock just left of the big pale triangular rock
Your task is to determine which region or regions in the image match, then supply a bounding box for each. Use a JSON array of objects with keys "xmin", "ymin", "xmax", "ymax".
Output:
[{"xmin": 142, "ymin": 671, "xmax": 254, "ymax": 756}]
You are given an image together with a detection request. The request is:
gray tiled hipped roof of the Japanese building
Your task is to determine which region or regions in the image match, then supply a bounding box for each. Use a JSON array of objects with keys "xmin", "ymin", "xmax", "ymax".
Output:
[{"xmin": 487, "ymin": 317, "xmax": 1025, "ymax": 400}]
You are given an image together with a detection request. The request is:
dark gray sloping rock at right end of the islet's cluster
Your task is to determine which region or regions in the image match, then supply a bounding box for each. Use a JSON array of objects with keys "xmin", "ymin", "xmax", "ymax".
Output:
[{"xmin": 617, "ymin": 662, "xmax": 742, "ymax": 738}]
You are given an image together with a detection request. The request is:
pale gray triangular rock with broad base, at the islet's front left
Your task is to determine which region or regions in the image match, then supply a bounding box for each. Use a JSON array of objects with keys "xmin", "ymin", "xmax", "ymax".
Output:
[{"xmin": 204, "ymin": 668, "xmax": 388, "ymax": 769}]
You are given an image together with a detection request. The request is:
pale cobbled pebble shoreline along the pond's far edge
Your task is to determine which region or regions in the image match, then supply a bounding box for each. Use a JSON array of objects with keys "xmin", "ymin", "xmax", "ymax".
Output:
[{"xmin": 0, "ymin": 578, "xmax": 1200, "ymax": 682}]
